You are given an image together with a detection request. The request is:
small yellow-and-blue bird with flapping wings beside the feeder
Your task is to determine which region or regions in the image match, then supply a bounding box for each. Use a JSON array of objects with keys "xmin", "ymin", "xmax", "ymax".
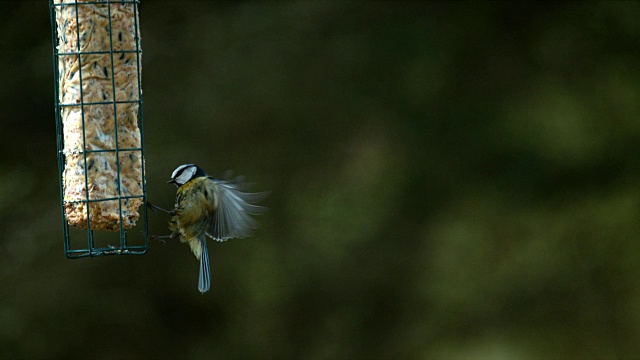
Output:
[{"xmin": 158, "ymin": 164, "xmax": 268, "ymax": 293}]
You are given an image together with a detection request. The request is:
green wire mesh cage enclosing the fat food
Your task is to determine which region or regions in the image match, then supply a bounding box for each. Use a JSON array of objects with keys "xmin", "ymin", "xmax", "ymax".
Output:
[{"xmin": 49, "ymin": 0, "xmax": 149, "ymax": 259}]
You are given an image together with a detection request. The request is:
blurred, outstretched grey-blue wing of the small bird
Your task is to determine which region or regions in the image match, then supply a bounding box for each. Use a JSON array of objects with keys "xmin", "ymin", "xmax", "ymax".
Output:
[{"xmin": 207, "ymin": 178, "xmax": 268, "ymax": 241}]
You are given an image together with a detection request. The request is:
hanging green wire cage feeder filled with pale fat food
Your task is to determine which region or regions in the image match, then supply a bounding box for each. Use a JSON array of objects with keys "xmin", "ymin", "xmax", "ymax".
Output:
[{"xmin": 49, "ymin": 0, "xmax": 149, "ymax": 258}]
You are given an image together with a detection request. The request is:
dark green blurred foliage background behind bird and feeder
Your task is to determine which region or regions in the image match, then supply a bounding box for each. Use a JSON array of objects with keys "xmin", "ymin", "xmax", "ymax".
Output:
[{"xmin": 0, "ymin": 1, "xmax": 640, "ymax": 359}]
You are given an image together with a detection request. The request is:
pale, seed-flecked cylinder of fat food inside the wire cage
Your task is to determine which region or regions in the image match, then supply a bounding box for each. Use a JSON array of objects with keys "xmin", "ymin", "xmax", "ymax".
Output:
[{"xmin": 54, "ymin": 0, "xmax": 144, "ymax": 231}]
